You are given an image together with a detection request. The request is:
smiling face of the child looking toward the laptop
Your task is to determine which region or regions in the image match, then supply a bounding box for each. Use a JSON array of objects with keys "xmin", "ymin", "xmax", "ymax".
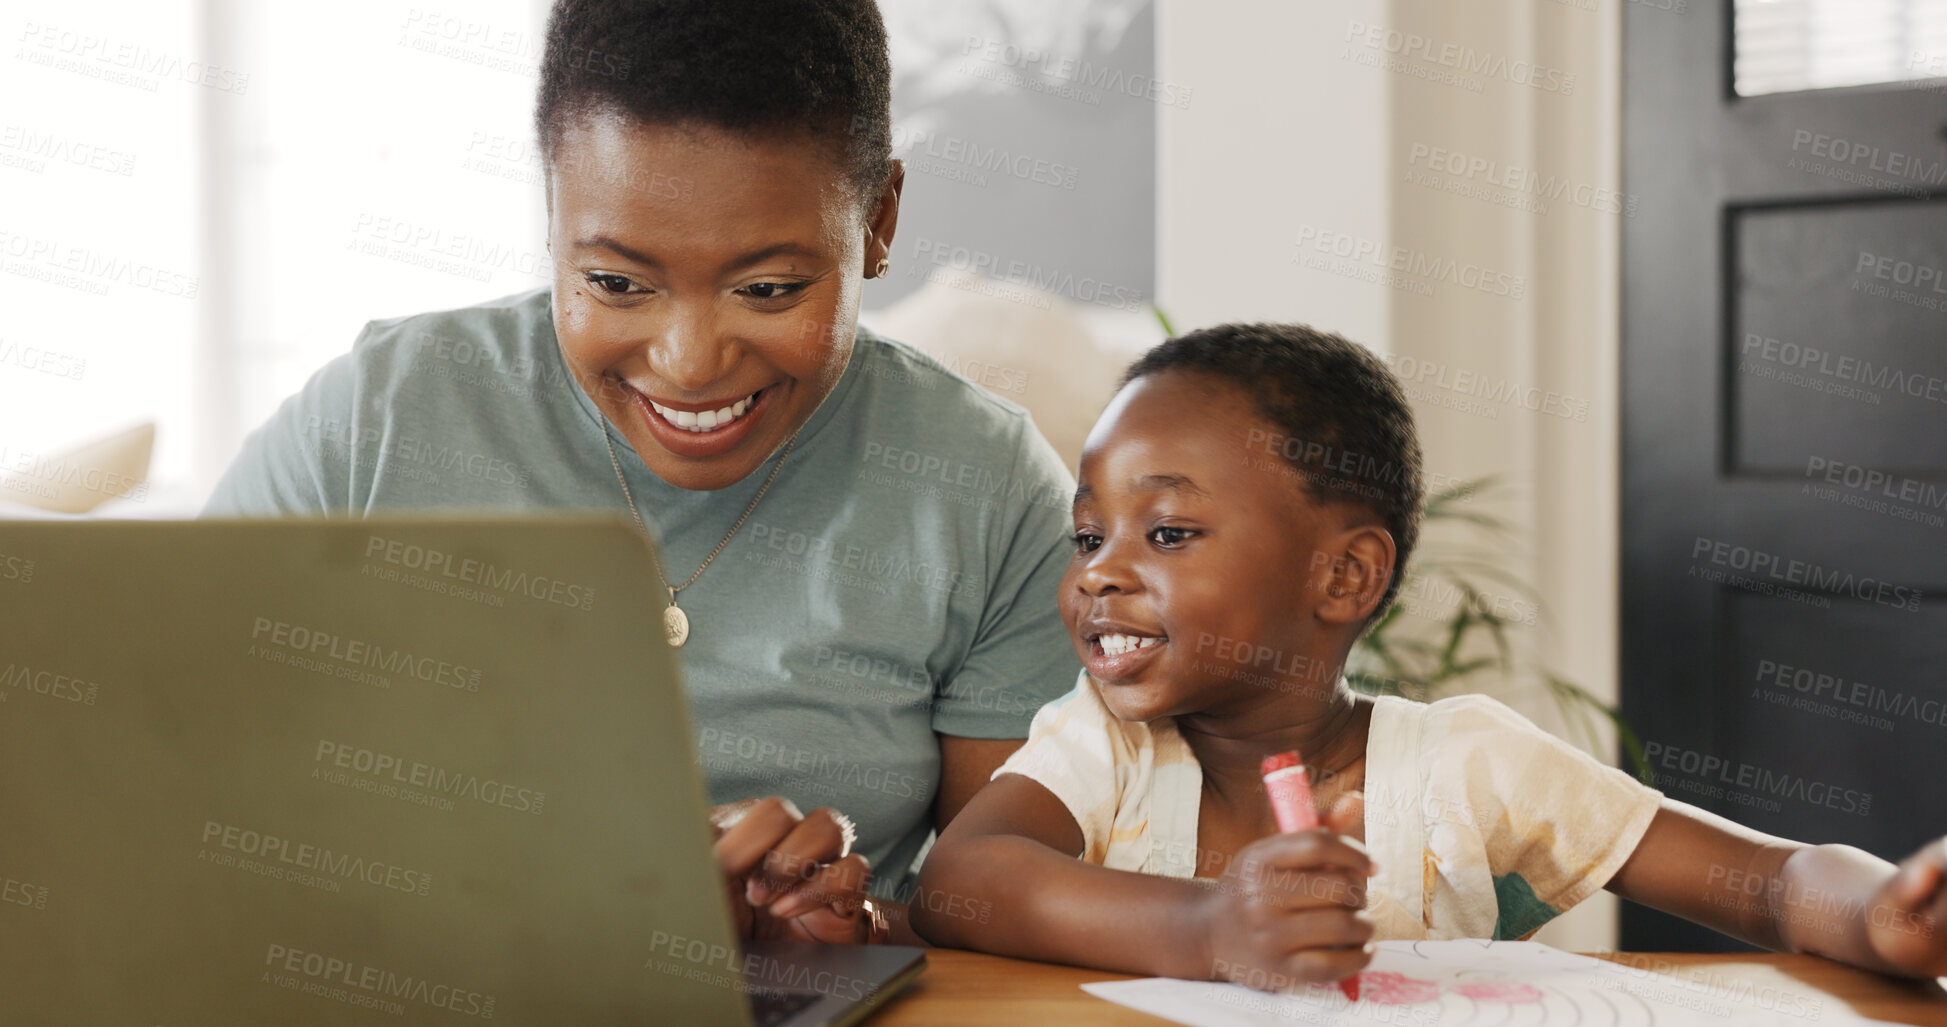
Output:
[{"xmin": 1061, "ymin": 370, "xmax": 1347, "ymax": 721}]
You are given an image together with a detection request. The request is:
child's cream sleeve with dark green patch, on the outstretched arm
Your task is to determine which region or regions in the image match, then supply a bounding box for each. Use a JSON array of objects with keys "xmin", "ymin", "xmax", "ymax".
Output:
[{"xmin": 1435, "ymin": 696, "xmax": 1663, "ymax": 937}]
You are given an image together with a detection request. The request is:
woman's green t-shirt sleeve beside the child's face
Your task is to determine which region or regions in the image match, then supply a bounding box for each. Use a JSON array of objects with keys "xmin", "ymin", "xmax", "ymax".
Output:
[{"xmin": 933, "ymin": 419, "xmax": 1081, "ymax": 739}]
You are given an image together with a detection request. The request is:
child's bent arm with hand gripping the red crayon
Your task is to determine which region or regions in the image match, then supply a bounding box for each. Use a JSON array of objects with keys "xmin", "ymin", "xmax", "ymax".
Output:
[{"xmin": 911, "ymin": 774, "xmax": 1373, "ymax": 986}]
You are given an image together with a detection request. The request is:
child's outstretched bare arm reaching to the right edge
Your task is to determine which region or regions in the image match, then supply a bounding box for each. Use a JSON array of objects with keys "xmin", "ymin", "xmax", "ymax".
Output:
[{"xmin": 1608, "ymin": 799, "xmax": 1947, "ymax": 976}]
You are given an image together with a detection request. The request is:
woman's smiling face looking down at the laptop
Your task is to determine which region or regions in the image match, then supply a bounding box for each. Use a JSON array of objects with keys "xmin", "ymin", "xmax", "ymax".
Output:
[{"xmin": 547, "ymin": 113, "xmax": 901, "ymax": 489}]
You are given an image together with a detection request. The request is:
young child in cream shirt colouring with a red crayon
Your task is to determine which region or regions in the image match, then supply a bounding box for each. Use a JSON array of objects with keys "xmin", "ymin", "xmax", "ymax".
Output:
[{"xmin": 913, "ymin": 325, "xmax": 1947, "ymax": 986}]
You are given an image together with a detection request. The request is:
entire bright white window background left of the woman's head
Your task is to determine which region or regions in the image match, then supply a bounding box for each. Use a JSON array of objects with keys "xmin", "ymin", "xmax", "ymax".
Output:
[{"xmin": 0, "ymin": 0, "xmax": 564, "ymax": 514}]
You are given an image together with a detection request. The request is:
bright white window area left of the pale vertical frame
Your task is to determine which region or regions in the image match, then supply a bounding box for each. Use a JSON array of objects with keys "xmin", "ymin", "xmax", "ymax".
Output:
[{"xmin": 0, "ymin": 0, "xmax": 201, "ymax": 503}]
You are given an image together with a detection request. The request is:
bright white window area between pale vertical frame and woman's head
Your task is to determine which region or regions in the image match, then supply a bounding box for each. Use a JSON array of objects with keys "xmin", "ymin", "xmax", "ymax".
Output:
[{"xmin": 195, "ymin": 0, "xmax": 553, "ymax": 491}]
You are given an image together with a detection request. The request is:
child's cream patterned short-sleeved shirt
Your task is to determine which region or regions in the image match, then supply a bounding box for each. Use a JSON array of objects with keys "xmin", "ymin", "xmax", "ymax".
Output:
[{"xmin": 995, "ymin": 674, "xmax": 1663, "ymax": 939}]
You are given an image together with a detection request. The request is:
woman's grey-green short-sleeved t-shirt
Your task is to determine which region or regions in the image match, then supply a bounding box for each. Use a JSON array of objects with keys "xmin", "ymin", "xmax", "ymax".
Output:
[{"xmin": 204, "ymin": 290, "xmax": 1079, "ymax": 896}]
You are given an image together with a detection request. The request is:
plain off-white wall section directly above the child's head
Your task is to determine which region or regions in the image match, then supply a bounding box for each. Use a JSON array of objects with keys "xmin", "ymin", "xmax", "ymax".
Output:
[{"xmin": 1157, "ymin": 0, "xmax": 1390, "ymax": 351}]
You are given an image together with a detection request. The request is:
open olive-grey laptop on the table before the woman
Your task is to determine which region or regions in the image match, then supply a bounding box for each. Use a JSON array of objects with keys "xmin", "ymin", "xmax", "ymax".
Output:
[{"xmin": 0, "ymin": 516, "xmax": 925, "ymax": 1027}]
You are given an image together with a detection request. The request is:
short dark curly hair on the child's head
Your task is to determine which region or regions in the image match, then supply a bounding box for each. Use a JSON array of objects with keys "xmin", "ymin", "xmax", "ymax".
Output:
[{"xmin": 1121, "ymin": 323, "xmax": 1425, "ymax": 620}]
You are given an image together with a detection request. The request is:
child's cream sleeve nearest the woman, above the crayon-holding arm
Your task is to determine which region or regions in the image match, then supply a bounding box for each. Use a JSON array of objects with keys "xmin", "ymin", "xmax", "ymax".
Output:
[{"xmin": 993, "ymin": 674, "xmax": 1123, "ymax": 863}]
